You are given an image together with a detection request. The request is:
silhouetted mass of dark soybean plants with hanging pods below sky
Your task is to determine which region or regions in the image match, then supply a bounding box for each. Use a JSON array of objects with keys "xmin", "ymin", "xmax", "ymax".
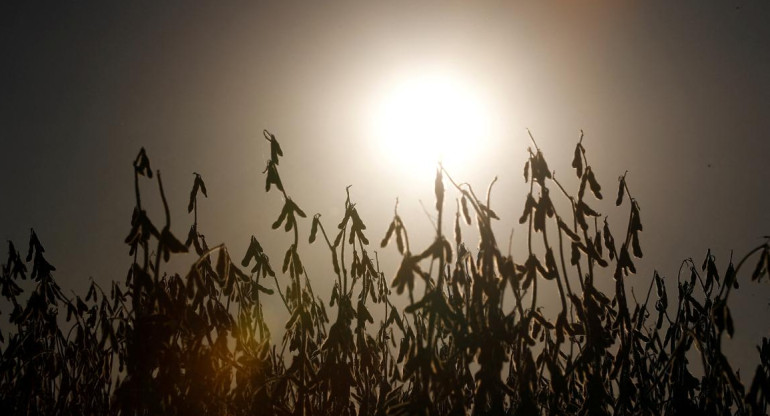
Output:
[{"xmin": 0, "ymin": 131, "xmax": 770, "ymax": 416}]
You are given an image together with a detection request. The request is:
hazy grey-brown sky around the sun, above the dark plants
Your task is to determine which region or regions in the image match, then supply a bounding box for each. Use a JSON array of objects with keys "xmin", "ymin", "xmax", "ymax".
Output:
[{"xmin": 0, "ymin": 1, "xmax": 770, "ymax": 374}]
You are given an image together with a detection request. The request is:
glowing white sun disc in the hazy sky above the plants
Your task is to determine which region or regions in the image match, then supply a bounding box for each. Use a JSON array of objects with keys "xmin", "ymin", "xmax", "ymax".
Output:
[{"xmin": 373, "ymin": 74, "xmax": 490, "ymax": 176}]
